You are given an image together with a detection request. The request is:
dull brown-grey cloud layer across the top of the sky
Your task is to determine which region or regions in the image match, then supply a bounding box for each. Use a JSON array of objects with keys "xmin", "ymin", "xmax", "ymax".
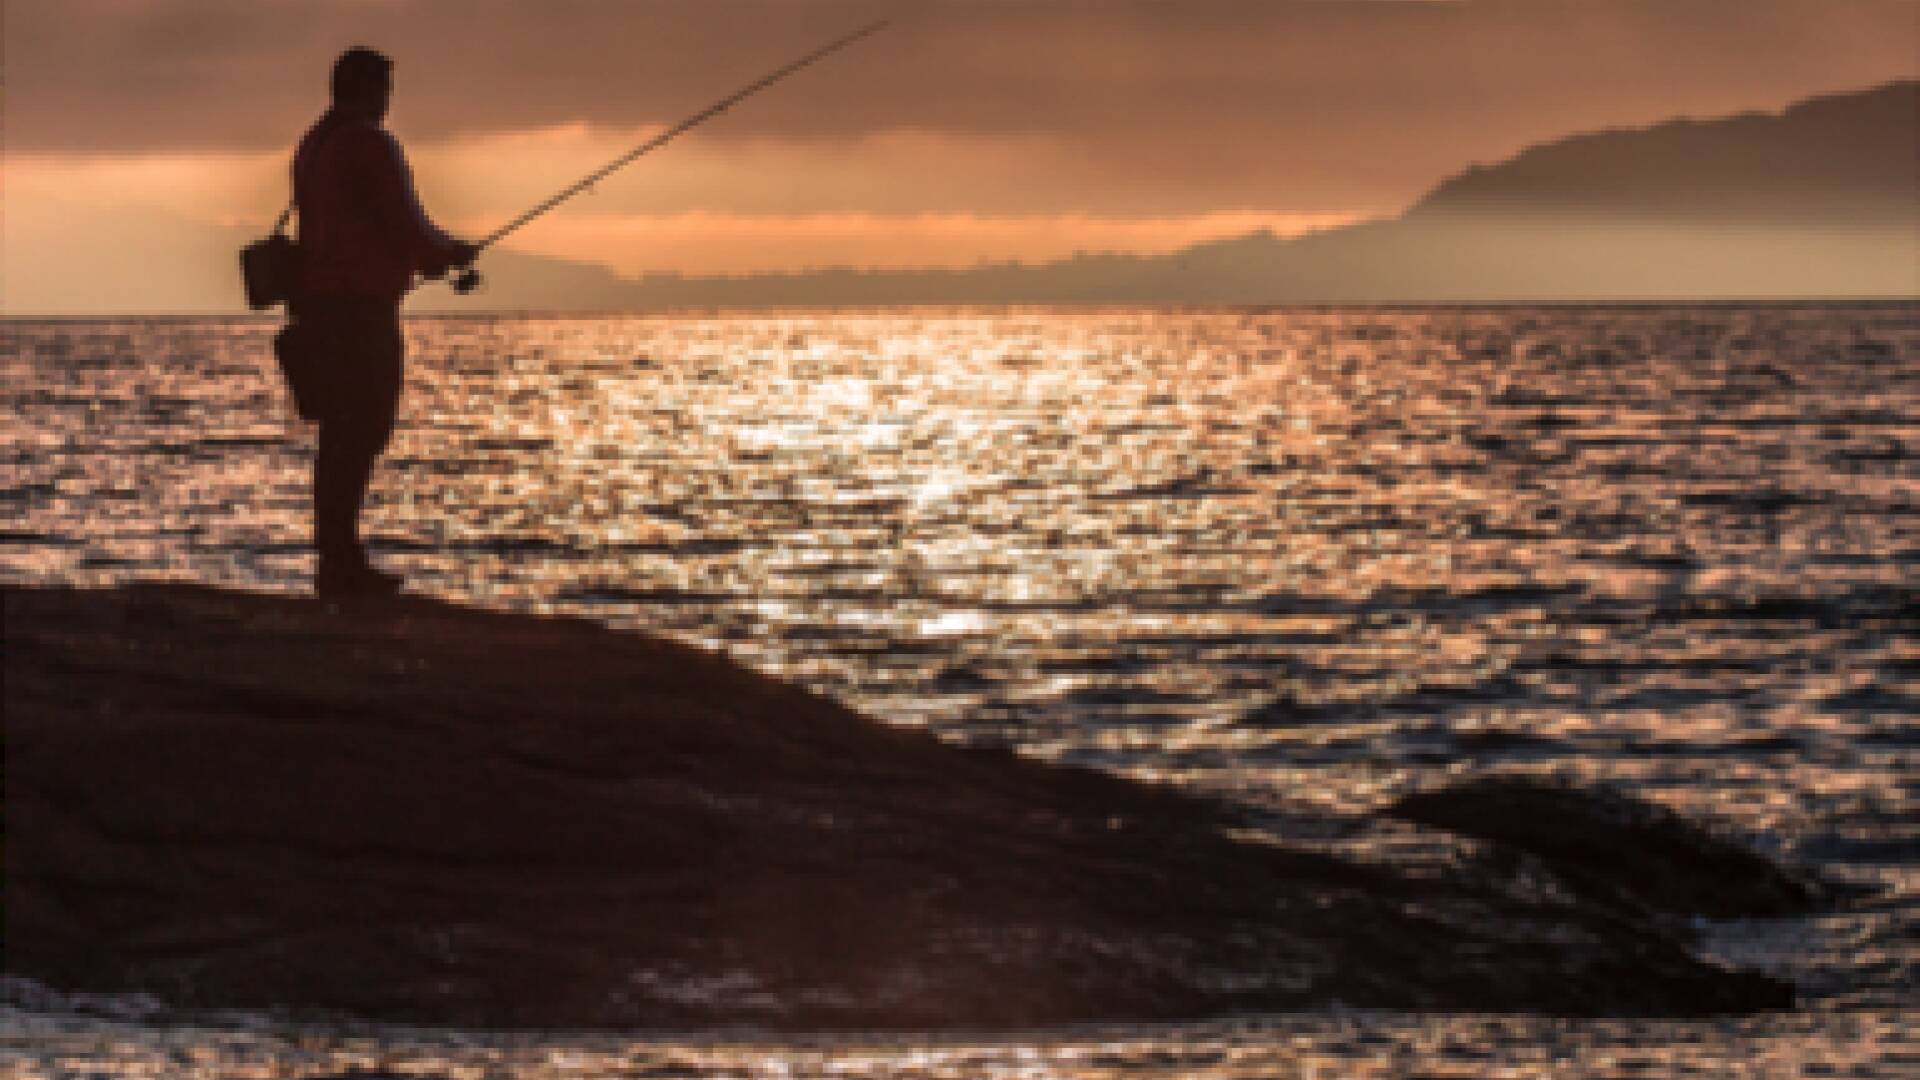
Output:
[{"xmin": 6, "ymin": 0, "xmax": 1916, "ymax": 213}]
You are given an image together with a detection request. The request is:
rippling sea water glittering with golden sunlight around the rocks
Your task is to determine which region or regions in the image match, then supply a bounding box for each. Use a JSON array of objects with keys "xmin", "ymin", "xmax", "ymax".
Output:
[{"xmin": 0, "ymin": 306, "xmax": 1920, "ymax": 1078}]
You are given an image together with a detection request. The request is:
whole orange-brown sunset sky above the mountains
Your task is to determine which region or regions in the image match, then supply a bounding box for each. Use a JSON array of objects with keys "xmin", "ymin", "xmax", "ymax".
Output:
[{"xmin": 0, "ymin": 0, "xmax": 1920, "ymax": 309}]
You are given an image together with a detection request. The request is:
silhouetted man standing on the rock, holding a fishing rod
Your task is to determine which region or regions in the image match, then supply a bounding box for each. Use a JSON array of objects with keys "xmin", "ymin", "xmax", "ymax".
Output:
[{"xmin": 290, "ymin": 48, "xmax": 476, "ymax": 596}]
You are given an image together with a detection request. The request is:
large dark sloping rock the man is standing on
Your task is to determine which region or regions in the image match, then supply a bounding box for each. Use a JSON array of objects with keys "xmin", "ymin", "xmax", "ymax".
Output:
[{"xmin": 4, "ymin": 586, "xmax": 1791, "ymax": 1028}]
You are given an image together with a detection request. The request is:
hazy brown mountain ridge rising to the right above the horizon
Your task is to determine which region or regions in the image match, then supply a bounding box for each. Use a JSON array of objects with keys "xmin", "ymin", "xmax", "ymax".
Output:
[{"xmin": 439, "ymin": 81, "xmax": 1920, "ymax": 307}]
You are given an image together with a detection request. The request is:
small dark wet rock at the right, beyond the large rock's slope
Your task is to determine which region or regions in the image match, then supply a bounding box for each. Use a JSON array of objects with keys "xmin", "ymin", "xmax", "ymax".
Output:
[{"xmin": 1386, "ymin": 778, "xmax": 1832, "ymax": 919}]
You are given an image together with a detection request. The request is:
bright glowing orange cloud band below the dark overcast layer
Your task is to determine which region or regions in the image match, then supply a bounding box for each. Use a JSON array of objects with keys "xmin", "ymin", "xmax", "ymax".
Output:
[{"xmin": 8, "ymin": 123, "xmax": 1394, "ymax": 233}]
